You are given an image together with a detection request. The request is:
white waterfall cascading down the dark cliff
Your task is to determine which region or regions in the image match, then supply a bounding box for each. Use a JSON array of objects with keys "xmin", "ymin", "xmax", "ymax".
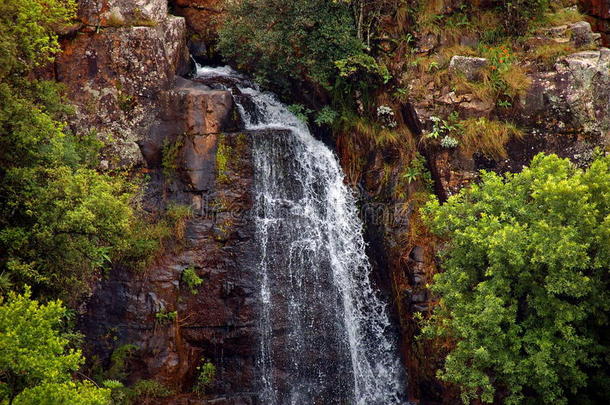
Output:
[{"xmin": 198, "ymin": 68, "xmax": 406, "ymax": 405}]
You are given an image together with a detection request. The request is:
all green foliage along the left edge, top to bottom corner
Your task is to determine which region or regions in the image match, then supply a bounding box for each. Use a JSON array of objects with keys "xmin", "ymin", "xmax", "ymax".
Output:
[{"xmin": 0, "ymin": 0, "xmax": 179, "ymax": 405}]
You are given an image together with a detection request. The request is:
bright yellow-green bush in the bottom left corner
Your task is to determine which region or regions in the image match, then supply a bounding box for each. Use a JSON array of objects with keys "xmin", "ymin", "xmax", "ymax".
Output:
[{"xmin": 0, "ymin": 288, "xmax": 110, "ymax": 405}]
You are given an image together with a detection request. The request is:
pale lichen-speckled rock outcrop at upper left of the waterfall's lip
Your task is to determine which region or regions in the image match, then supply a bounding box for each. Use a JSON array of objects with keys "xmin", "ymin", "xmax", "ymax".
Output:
[{"xmin": 54, "ymin": 0, "xmax": 189, "ymax": 167}]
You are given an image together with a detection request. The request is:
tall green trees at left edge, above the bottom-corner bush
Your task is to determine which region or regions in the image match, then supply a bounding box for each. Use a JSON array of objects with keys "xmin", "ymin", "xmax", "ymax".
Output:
[{"xmin": 0, "ymin": 0, "xmax": 135, "ymax": 304}]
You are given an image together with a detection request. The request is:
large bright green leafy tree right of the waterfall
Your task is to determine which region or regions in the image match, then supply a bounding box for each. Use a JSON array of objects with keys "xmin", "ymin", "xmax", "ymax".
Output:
[{"xmin": 424, "ymin": 154, "xmax": 610, "ymax": 404}]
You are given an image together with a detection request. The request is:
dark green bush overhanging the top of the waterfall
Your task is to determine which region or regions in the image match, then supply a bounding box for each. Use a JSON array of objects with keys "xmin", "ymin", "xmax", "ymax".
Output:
[{"xmin": 219, "ymin": 0, "xmax": 363, "ymax": 93}]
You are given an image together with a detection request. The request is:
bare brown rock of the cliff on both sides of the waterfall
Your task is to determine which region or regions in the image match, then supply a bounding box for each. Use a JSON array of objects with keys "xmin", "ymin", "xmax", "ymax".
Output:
[{"xmin": 36, "ymin": 0, "xmax": 610, "ymax": 405}]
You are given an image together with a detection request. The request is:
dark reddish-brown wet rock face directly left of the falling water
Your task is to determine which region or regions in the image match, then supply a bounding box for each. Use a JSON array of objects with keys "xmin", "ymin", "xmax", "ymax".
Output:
[{"xmin": 83, "ymin": 129, "xmax": 258, "ymax": 404}]
